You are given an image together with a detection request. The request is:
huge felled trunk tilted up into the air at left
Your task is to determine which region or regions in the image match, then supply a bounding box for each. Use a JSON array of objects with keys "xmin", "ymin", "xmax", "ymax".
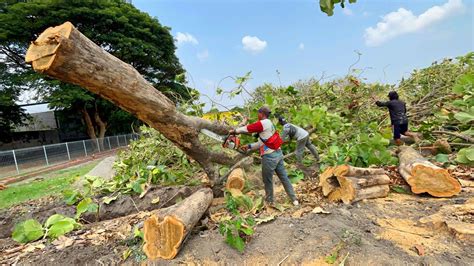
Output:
[{"xmin": 25, "ymin": 22, "xmax": 241, "ymax": 183}]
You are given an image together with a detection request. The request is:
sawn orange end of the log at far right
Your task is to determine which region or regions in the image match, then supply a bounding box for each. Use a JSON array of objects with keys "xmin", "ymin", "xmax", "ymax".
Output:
[{"xmin": 407, "ymin": 164, "xmax": 461, "ymax": 197}]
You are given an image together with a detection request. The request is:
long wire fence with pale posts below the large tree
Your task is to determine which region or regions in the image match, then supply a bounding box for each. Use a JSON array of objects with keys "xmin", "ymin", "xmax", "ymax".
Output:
[{"xmin": 0, "ymin": 134, "xmax": 139, "ymax": 179}]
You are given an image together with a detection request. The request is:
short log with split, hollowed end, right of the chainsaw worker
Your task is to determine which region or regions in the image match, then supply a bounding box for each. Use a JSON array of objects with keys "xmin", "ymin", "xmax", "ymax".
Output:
[{"xmin": 319, "ymin": 165, "xmax": 390, "ymax": 204}]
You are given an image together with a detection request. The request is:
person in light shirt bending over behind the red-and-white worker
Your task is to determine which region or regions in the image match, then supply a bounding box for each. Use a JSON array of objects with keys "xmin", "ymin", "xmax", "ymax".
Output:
[{"xmin": 278, "ymin": 116, "xmax": 319, "ymax": 172}]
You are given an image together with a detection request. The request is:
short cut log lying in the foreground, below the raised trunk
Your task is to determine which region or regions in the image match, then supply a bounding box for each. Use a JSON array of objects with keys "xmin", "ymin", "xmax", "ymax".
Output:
[{"xmin": 143, "ymin": 188, "xmax": 213, "ymax": 259}]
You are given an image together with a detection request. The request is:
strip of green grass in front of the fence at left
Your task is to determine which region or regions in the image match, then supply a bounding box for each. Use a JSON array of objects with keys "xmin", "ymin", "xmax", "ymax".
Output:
[{"xmin": 0, "ymin": 162, "xmax": 98, "ymax": 209}]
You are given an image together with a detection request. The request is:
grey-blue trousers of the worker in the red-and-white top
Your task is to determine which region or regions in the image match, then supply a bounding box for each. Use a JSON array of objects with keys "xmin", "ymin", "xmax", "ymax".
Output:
[{"xmin": 262, "ymin": 150, "xmax": 296, "ymax": 203}]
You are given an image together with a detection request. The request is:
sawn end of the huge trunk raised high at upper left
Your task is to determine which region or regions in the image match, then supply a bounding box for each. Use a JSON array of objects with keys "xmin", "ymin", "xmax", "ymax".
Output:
[{"xmin": 25, "ymin": 22, "xmax": 74, "ymax": 69}]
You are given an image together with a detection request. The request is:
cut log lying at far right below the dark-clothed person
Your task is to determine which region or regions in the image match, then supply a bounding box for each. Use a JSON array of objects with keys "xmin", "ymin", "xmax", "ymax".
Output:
[{"xmin": 398, "ymin": 146, "xmax": 461, "ymax": 197}]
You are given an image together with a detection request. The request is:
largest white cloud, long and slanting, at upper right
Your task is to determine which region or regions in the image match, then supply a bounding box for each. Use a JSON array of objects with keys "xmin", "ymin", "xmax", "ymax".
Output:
[{"xmin": 364, "ymin": 0, "xmax": 463, "ymax": 46}]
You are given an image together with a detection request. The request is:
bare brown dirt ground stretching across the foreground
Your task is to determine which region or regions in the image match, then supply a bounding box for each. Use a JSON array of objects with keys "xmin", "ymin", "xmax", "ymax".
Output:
[{"xmin": 0, "ymin": 165, "xmax": 474, "ymax": 265}]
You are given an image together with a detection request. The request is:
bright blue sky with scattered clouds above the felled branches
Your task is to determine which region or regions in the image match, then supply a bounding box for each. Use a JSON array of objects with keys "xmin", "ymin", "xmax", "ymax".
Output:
[{"xmin": 25, "ymin": 0, "xmax": 474, "ymax": 112}]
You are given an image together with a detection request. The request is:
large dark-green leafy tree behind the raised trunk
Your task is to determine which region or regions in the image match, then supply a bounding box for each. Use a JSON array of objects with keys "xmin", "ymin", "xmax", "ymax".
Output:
[{"xmin": 0, "ymin": 0, "xmax": 191, "ymax": 138}]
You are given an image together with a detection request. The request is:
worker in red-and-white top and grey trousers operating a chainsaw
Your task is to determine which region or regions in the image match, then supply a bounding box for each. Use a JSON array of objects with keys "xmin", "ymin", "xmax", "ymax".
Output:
[{"xmin": 229, "ymin": 106, "xmax": 299, "ymax": 206}]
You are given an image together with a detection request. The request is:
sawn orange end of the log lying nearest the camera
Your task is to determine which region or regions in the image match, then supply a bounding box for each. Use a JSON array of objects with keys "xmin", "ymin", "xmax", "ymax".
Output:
[{"xmin": 143, "ymin": 216, "xmax": 186, "ymax": 259}]
